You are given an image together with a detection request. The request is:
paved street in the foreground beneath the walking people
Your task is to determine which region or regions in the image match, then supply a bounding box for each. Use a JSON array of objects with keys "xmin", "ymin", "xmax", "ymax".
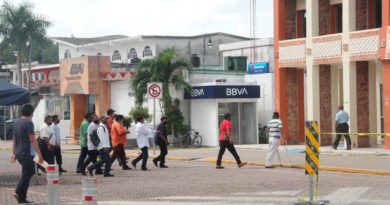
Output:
[{"xmin": 0, "ymin": 148, "xmax": 390, "ymax": 205}]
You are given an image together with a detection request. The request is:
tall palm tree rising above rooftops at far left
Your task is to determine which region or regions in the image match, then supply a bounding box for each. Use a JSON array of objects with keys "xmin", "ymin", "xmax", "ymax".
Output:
[{"xmin": 0, "ymin": 1, "xmax": 51, "ymax": 86}]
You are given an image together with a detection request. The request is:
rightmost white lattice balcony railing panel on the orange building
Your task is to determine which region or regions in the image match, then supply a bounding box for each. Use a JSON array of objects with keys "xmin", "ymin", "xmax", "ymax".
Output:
[{"xmin": 349, "ymin": 29, "xmax": 379, "ymax": 61}]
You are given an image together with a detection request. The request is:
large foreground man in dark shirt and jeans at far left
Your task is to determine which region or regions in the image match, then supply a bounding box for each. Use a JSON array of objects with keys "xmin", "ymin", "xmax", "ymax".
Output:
[{"xmin": 11, "ymin": 104, "xmax": 43, "ymax": 204}]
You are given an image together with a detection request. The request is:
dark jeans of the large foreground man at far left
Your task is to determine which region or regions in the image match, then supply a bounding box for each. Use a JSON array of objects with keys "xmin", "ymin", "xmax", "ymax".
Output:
[{"xmin": 15, "ymin": 156, "xmax": 35, "ymax": 200}]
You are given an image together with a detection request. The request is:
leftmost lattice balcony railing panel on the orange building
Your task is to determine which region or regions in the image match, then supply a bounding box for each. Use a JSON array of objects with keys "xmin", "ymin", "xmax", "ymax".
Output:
[{"xmin": 279, "ymin": 38, "xmax": 306, "ymax": 67}]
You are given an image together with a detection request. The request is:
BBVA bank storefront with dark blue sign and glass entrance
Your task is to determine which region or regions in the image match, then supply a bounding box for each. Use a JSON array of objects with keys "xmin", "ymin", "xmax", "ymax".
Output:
[{"xmin": 184, "ymin": 83, "xmax": 260, "ymax": 146}]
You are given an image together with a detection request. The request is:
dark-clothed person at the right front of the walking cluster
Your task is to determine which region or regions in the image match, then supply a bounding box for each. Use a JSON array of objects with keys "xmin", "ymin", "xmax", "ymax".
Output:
[{"xmin": 153, "ymin": 117, "xmax": 169, "ymax": 168}]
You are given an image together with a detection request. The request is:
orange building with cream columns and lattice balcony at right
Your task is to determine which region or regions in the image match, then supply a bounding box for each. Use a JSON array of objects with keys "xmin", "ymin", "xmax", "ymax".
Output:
[{"xmin": 274, "ymin": 0, "xmax": 390, "ymax": 149}]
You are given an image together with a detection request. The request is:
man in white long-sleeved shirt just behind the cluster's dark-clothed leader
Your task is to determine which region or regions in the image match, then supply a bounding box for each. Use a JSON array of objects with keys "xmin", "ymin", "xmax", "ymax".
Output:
[{"xmin": 131, "ymin": 116, "xmax": 154, "ymax": 171}]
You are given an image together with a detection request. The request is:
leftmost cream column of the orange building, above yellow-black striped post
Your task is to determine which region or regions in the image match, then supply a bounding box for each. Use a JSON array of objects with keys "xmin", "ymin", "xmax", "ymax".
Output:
[{"xmin": 306, "ymin": 1, "xmax": 321, "ymax": 121}]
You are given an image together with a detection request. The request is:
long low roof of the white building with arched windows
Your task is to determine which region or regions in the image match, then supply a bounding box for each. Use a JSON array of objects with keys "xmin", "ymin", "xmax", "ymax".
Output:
[{"xmin": 51, "ymin": 32, "xmax": 249, "ymax": 46}]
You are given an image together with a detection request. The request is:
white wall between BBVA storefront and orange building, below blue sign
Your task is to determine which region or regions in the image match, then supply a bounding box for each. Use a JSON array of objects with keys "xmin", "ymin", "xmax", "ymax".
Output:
[{"xmin": 245, "ymin": 73, "xmax": 275, "ymax": 126}]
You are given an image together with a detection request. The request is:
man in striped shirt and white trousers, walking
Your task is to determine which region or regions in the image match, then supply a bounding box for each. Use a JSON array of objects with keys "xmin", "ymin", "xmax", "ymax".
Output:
[{"xmin": 265, "ymin": 112, "xmax": 282, "ymax": 168}]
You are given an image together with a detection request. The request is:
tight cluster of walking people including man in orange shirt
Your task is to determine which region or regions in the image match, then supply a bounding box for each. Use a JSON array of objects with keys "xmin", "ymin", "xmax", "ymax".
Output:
[{"xmin": 76, "ymin": 109, "xmax": 169, "ymax": 177}]
